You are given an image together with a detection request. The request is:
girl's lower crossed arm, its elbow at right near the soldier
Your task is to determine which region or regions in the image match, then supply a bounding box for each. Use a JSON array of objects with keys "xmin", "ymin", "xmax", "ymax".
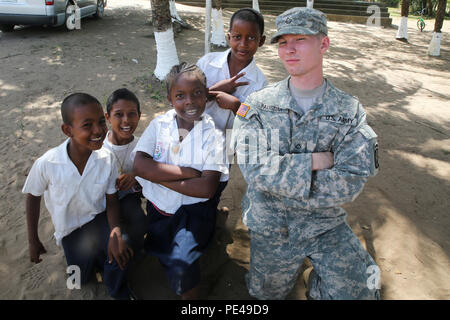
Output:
[{"xmin": 160, "ymin": 170, "xmax": 220, "ymax": 199}]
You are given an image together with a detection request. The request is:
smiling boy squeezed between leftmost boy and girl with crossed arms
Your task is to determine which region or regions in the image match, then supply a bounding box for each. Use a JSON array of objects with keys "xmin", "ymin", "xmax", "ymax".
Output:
[{"xmin": 103, "ymin": 88, "xmax": 147, "ymax": 253}]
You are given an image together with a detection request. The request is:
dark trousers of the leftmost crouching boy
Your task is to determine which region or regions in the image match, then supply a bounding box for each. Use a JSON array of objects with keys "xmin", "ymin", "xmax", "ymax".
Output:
[{"xmin": 62, "ymin": 212, "xmax": 129, "ymax": 299}]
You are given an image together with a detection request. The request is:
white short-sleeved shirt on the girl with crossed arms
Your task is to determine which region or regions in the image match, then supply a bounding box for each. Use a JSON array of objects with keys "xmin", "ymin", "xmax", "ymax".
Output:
[{"xmin": 133, "ymin": 109, "xmax": 228, "ymax": 214}]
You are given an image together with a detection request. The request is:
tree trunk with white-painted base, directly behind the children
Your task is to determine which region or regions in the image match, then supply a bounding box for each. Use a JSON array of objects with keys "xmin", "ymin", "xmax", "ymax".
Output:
[{"xmin": 150, "ymin": 0, "xmax": 179, "ymax": 81}]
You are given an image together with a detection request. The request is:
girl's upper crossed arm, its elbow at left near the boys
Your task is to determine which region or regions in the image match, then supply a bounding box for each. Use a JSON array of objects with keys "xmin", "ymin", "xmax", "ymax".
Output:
[{"xmin": 133, "ymin": 151, "xmax": 201, "ymax": 183}]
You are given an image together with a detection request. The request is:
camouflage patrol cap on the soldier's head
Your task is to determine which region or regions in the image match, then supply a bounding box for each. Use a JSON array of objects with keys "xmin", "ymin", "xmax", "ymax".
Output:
[{"xmin": 270, "ymin": 7, "xmax": 328, "ymax": 43}]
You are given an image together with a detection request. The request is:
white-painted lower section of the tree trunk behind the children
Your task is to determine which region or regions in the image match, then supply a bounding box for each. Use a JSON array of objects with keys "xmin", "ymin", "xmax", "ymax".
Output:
[{"xmin": 154, "ymin": 27, "xmax": 179, "ymax": 81}]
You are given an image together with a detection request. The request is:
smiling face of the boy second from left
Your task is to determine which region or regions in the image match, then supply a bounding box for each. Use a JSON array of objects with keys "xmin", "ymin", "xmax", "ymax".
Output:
[{"xmin": 105, "ymin": 99, "xmax": 141, "ymax": 141}]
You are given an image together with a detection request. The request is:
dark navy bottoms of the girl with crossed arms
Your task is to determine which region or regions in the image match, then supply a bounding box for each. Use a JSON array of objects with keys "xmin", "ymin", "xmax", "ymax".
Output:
[{"xmin": 145, "ymin": 201, "xmax": 216, "ymax": 295}]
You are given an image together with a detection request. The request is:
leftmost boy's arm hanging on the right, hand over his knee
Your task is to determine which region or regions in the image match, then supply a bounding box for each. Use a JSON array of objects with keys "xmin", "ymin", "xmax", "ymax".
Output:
[{"xmin": 106, "ymin": 193, "xmax": 133, "ymax": 270}]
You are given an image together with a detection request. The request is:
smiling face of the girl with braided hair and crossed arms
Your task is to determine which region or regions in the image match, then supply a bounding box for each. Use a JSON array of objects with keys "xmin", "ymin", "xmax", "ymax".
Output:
[{"xmin": 167, "ymin": 73, "xmax": 207, "ymax": 124}]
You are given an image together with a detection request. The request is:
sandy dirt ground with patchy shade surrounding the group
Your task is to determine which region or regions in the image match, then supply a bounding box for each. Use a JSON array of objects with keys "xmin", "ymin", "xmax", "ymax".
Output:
[{"xmin": 0, "ymin": 0, "xmax": 450, "ymax": 300}]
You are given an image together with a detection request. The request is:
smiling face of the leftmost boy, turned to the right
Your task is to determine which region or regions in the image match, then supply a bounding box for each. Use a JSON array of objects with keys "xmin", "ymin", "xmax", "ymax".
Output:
[{"xmin": 62, "ymin": 103, "xmax": 107, "ymax": 151}]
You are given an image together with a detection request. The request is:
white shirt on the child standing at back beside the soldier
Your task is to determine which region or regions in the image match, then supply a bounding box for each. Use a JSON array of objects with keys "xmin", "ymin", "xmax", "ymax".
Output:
[{"xmin": 197, "ymin": 49, "xmax": 268, "ymax": 134}]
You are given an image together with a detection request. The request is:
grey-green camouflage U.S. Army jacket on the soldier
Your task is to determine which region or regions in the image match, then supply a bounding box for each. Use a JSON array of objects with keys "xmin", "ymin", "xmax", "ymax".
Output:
[{"xmin": 231, "ymin": 78, "xmax": 378, "ymax": 240}]
